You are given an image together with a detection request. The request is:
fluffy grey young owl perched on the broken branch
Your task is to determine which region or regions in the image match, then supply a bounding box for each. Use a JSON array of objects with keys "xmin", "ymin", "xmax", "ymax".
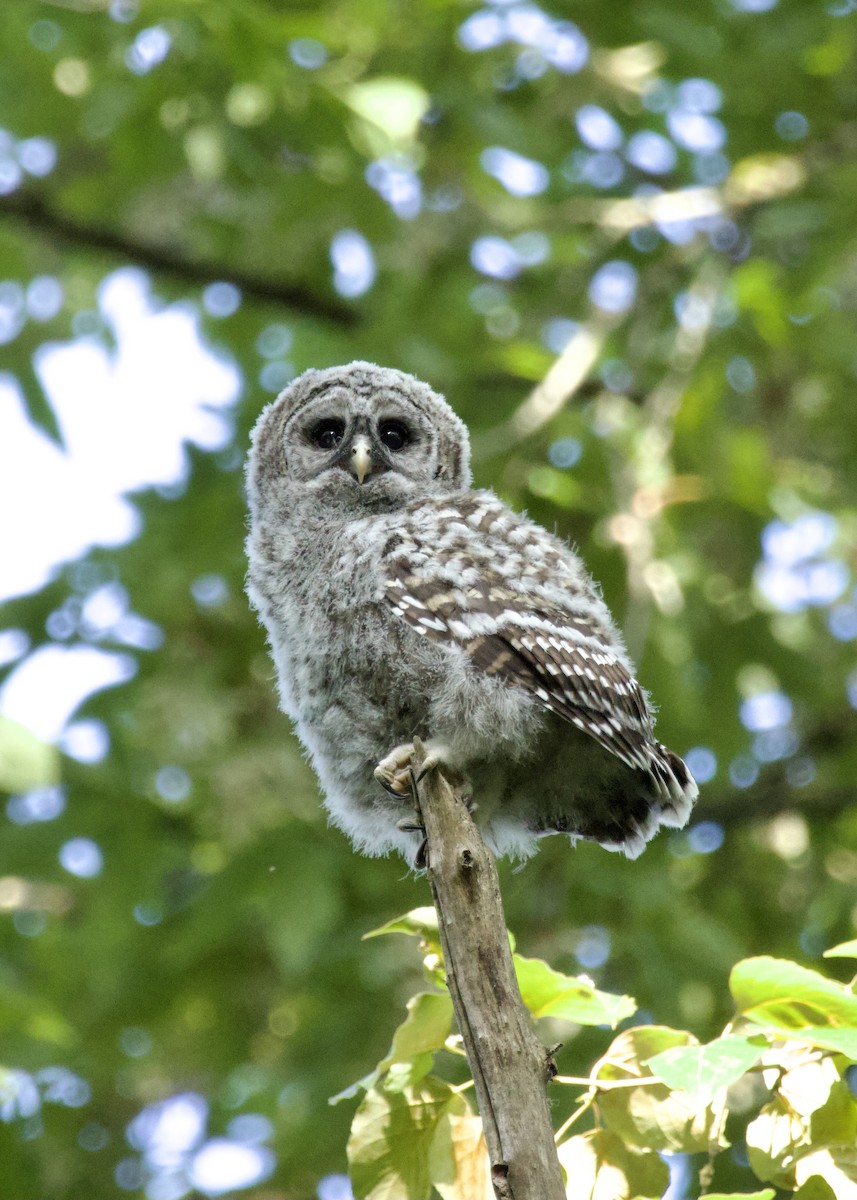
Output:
[{"xmin": 246, "ymin": 362, "xmax": 696, "ymax": 864}]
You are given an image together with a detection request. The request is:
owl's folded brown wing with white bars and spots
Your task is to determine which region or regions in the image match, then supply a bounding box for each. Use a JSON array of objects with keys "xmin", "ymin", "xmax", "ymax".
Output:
[{"xmin": 384, "ymin": 504, "xmax": 687, "ymax": 798}]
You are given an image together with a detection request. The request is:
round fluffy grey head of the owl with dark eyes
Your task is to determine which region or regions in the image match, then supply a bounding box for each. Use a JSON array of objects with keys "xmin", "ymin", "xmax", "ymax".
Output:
[{"xmin": 247, "ymin": 362, "xmax": 471, "ymax": 511}]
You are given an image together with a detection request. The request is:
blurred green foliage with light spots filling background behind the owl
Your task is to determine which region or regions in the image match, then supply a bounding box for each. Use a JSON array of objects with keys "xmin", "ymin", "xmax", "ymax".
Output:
[{"xmin": 0, "ymin": 0, "xmax": 857, "ymax": 1200}]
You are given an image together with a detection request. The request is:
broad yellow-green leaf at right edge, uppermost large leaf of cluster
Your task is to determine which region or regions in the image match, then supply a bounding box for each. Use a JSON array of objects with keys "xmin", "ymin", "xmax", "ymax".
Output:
[{"xmin": 729, "ymin": 958, "xmax": 857, "ymax": 1030}]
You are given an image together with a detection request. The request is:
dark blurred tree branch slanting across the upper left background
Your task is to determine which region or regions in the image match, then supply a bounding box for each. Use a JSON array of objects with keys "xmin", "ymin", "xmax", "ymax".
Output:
[{"xmin": 0, "ymin": 192, "xmax": 359, "ymax": 325}]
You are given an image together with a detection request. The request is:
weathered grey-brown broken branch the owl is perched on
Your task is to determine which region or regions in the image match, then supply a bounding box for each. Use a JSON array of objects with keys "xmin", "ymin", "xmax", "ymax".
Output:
[{"xmin": 413, "ymin": 742, "xmax": 565, "ymax": 1200}]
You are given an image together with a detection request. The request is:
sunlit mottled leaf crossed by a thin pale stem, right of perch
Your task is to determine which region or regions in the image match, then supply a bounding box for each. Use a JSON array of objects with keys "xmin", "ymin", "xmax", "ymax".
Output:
[{"xmin": 593, "ymin": 1025, "xmax": 718, "ymax": 1153}]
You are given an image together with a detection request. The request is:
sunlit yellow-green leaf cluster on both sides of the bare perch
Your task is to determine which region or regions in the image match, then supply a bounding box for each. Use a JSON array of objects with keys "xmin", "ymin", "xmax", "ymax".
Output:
[{"xmin": 343, "ymin": 908, "xmax": 857, "ymax": 1200}]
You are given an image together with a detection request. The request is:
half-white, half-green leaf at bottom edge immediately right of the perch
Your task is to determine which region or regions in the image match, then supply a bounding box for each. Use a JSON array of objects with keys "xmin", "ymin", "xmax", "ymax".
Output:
[{"xmin": 557, "ymin": 1129, "xmax": 670, "ymax": 1200}]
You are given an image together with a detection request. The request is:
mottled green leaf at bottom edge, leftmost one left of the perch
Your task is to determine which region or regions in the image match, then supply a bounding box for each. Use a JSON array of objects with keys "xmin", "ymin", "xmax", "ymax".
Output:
[{"xmin": 348, "ymin": 1079, "xmax": 467, "ymax": 1200}]
